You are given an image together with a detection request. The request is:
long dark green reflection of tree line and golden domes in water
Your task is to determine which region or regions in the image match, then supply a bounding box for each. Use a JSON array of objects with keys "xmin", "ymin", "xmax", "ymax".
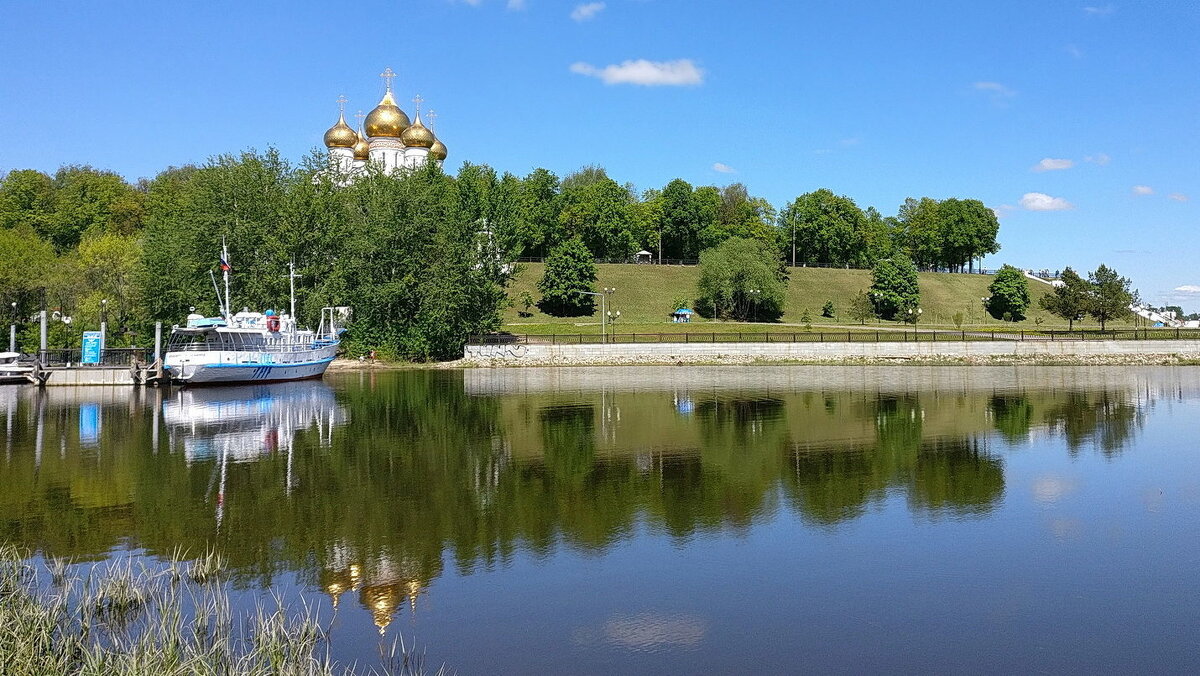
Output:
[{"xmin": 0, "ymin": 371, "xmax": 1156, "ymax": 633}]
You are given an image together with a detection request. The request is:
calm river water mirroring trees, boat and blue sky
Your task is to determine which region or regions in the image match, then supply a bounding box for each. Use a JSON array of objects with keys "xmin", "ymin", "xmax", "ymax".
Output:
[{"xmin": 0, "ymin": 366, "xmax": 1200, "ymax": 674}]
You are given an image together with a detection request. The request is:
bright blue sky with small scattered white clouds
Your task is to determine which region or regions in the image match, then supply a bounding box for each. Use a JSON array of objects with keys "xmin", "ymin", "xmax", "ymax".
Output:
[{"xmin": 0, "ymin": 0, "xmax": 1200, "ymax": 310}]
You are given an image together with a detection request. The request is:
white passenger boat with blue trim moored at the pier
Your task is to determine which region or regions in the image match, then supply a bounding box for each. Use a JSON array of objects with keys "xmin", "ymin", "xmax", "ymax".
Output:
[{"xmin": 163, "ymin": 252, "xmax": 350, "ymax": 384}]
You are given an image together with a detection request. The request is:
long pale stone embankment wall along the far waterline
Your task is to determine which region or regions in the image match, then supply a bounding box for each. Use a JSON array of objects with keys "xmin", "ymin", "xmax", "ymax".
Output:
[{"xmin": 462, "ymin": 340, "xmax": 1200, "ymax": 366}]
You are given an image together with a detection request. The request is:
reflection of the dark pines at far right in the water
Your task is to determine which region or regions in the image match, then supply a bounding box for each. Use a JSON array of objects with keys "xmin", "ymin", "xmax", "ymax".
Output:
[{"xmin": 1045, "ymin": 391, "xmax": 1144, "ymax": 456}]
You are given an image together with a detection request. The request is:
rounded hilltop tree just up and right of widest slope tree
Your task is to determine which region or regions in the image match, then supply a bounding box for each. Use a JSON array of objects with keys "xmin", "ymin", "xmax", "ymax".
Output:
[{"xmin": 779, "ymin": 189, "xmax": 868, "ymax": 267}]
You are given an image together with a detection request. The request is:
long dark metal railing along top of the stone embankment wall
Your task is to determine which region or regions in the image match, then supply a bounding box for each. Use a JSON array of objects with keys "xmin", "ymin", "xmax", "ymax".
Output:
[{"xmin": 467, "ymin": 329, "xmax": 1200, "ymax": 345}]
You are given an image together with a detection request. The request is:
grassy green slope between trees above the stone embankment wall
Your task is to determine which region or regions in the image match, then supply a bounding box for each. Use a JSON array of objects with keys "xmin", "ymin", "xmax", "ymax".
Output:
[{"xmin": 504, "ymin": 263, "xmax": 1079, "ymax": 333}]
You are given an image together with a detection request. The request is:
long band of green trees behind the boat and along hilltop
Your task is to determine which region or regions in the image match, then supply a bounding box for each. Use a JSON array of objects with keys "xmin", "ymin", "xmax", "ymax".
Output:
[{"xmin": 0, "ymin": 150, "xmax": 998, "ymax": 359}]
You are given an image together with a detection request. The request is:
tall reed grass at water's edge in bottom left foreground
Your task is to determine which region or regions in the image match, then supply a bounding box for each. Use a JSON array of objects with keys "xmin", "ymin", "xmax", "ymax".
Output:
[{"xmin": 0, "ymin": 545, "xmax": 444, "ymax": 676}]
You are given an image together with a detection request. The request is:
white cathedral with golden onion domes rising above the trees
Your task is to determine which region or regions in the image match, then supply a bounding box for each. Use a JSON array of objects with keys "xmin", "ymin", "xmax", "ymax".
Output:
[{"xmin": 325, "ymin": 68, "xmax": 446, "ymax": 180}]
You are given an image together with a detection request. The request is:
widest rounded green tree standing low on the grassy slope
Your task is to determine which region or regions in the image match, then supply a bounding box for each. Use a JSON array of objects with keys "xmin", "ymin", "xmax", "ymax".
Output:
[{"xmin": 697, "ymin": 238, "xmax": 787, "ymax": 321}]
